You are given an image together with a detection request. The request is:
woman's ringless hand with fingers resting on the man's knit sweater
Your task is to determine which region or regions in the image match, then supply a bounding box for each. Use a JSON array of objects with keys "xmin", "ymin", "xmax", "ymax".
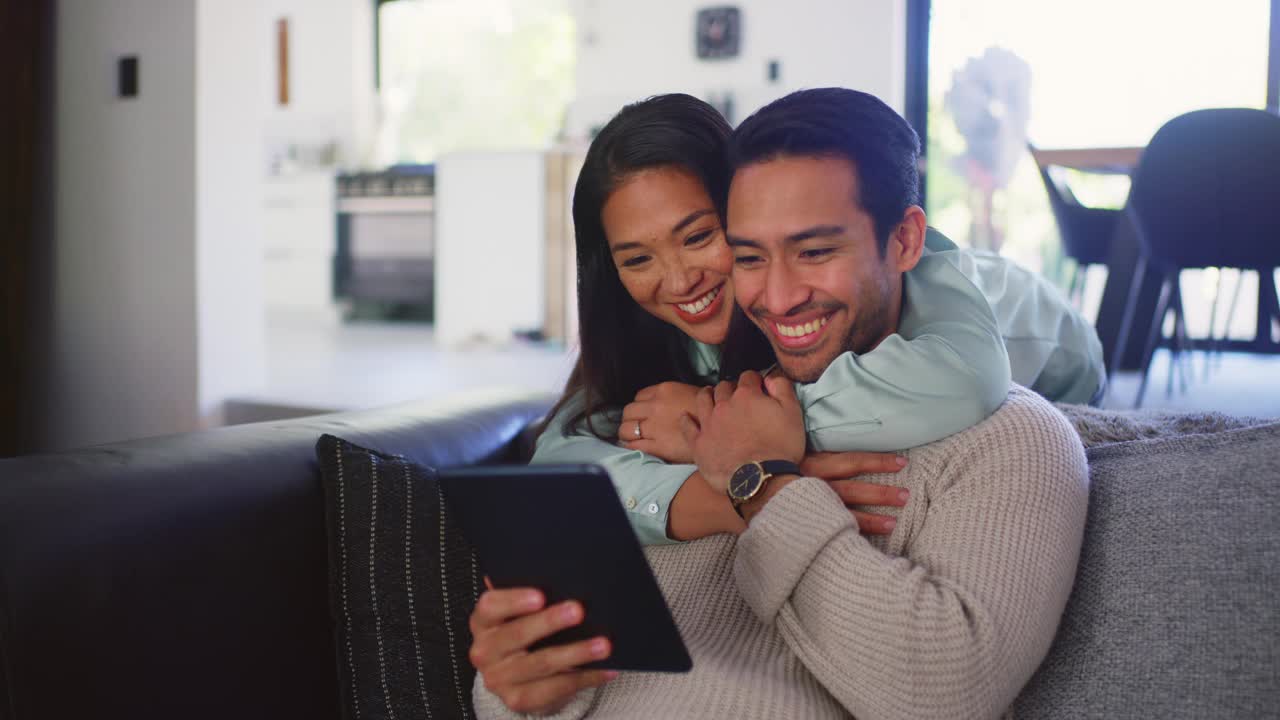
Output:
[{"xmin": 800, "ymin": 452, "xmax": 909, "ymax": 536}]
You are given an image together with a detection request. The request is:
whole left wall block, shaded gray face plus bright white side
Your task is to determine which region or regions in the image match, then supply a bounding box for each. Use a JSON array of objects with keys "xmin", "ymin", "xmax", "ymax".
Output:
[{"xmin": 46, "ymin": 0, "xmax": 265, "ymax": 450}]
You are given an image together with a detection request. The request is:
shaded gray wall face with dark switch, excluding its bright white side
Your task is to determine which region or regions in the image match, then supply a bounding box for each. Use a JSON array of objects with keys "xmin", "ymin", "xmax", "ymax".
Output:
[{"xmin": 50, "ymin": 0, "xmax": 197, "ymax": 448}]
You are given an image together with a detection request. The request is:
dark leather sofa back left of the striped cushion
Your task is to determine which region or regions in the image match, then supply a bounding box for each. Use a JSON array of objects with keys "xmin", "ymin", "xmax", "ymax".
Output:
[{"xmin": 0, "ymin": 392, "xmax": 553, "ymax": 720}]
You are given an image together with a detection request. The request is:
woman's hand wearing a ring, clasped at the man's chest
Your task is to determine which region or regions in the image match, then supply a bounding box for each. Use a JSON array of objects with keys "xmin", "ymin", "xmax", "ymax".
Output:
[{"xmin": 618, "ymin": 382, "xmax": 701, "ymax": 464}]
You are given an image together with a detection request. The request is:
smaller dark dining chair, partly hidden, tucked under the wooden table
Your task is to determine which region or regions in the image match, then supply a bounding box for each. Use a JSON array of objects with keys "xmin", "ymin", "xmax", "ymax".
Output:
[{"xmin": 1027, "ymin": 142, "xmax": 1121, "ymax": 305}]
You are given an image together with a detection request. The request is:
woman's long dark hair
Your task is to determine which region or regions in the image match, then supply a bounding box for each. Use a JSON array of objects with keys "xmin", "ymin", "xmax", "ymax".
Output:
[{"xmin": 549, "ymin": 94, "xmax": 732, "ymax": 438}]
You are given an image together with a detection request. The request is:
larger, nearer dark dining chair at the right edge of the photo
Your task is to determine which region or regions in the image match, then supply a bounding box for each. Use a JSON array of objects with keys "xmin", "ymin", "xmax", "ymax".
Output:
[{"xmin": 1116, "ymin": 108, "xmax": 1280, "ymax": 407}]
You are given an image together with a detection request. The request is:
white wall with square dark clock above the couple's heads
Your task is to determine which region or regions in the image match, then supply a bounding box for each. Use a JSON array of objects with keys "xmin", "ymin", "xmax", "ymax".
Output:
[{"xmin": 567, "ymin": 0, "xmax": 906, "ymax": 137}]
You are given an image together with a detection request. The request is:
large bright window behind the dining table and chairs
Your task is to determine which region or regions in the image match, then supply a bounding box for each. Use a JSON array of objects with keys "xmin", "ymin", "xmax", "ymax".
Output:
[{"xmin": 927, "ymin": 0, "xmax": 1274, "ymax": 272}]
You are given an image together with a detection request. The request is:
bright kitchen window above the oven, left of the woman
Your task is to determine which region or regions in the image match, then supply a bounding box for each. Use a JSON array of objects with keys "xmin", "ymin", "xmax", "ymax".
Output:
[{"xmin": 376, "ymin": 0, "xmax": 575, "ymax": 164}]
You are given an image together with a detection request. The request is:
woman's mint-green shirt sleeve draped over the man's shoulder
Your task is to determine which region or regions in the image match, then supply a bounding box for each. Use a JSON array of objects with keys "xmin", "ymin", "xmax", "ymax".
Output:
[{"xmin": 796, "ymin": 255, "xmax": 1010, "ymax": 452}]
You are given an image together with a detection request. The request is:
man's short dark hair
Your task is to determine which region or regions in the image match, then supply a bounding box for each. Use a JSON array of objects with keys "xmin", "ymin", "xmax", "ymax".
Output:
[{"xmin": 728, "ymin": 87, "xmax": 920, "ymax": 254}]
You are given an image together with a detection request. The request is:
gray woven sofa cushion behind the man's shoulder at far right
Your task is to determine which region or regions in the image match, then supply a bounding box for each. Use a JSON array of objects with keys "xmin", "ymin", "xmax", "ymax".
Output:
[{"xmin": 1015, "ymin": 423, "xmax": 1280, "ymax": 719}]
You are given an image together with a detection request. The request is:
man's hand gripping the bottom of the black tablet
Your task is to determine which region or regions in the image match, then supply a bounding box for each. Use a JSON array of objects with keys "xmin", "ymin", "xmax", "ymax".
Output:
[{"xmin": 470, "ymin": 579, "xmax": 617, "ymax": 714}]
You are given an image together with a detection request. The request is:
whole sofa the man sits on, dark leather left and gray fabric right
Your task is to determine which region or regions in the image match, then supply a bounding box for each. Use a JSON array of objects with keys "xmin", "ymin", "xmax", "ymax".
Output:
[{"xmin": 0, "ymin": 391, "xmax": 1280, "ymax": 720}]
